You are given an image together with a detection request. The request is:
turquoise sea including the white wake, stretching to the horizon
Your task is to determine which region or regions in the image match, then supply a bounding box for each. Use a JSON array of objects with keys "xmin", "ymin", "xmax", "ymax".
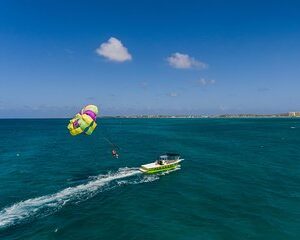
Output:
[{"xmin": 0, "ymin": 119, "xmax": 300, "ymax": 240}]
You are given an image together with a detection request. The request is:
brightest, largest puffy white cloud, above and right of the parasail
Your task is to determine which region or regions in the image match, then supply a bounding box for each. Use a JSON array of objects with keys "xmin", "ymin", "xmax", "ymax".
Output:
[{"xmin": 96, "ymin": 37, "xmax": 132, "ymax": 62}]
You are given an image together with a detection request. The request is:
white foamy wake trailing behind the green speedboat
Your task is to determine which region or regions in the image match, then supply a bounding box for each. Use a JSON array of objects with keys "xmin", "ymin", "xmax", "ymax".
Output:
[{"xmin": 0, "ymin": 168, "xmax": 159, "ymax": 230}]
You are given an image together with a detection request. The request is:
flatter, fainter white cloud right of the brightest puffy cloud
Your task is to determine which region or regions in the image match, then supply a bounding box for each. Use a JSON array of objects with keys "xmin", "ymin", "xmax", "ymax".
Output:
[{"xmin": 167, "ymin": 52, "xmax": 207, "ymax": 69}]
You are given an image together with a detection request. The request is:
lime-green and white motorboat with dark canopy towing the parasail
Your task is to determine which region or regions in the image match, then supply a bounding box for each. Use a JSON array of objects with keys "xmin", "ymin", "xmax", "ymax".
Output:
[{"xmin": 140, "ymin": 153, "xmax": 184, "ymax": 173}]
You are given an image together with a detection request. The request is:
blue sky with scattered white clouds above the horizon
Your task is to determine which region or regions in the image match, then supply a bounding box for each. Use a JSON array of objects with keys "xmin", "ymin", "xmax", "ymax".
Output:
[{"xmin": 0, "ymin": 0, "xmax": 300, "ymax": 118}]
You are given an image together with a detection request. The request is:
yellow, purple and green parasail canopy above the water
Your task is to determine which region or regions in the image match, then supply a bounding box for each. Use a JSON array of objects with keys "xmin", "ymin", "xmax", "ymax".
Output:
[{"xmin": 68, "ymin": 105, "xmax": 98, "ymax": 136}]
